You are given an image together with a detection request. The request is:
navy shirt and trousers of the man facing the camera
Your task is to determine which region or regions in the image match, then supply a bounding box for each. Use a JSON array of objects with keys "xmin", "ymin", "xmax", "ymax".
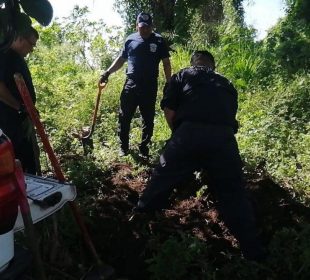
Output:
[{"xmin": 119, "ymin": 32, "xmax": 169, "ymax": 150}]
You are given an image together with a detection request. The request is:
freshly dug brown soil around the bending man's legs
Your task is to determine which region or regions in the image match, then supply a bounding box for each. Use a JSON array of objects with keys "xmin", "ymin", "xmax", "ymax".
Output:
[{"xmin": 80, "ymin": 164, "xmax": 310, "ymax": 280}]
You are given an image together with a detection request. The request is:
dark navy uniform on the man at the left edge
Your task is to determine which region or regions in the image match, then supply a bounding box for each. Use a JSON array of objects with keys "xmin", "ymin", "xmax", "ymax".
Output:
[{"xmin": 0, "ymin": 49, "xmax": 36, "ymax": 174}]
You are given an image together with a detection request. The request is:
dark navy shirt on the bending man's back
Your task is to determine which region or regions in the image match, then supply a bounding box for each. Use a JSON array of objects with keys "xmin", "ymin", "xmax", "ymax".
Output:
[{"xmin": 161, "ymin": 66, "xmax": 238, "ymax": 132}]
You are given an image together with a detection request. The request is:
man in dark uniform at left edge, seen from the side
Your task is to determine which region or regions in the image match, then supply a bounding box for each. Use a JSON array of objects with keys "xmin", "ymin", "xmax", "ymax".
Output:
[{"xmin": 0, "ymin": 26, "xmax": 40, "ymax": 174}]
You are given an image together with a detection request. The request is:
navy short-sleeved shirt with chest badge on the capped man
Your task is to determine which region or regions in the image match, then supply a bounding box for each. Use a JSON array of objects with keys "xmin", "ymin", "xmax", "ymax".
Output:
[{"xmin": 121, "ymin": 32, "xmax": 170, "ymax": 80}]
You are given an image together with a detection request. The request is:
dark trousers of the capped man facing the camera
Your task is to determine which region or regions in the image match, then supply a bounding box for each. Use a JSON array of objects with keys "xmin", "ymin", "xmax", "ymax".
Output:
[{"xmin": 118, "ymin": 78, "xmax": 157, "ymax": 149}]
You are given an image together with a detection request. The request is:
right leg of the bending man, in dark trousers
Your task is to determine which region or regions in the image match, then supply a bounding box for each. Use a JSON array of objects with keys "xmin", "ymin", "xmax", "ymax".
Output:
[{"xmin": 207, "ymin": 137, "xmax": 263, "ymax": 260}]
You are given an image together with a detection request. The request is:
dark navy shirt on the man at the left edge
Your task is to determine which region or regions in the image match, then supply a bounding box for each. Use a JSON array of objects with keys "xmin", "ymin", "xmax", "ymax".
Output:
[{"xmin": 0, "ymin": 49, "xmax": 36, "ymax": 108}]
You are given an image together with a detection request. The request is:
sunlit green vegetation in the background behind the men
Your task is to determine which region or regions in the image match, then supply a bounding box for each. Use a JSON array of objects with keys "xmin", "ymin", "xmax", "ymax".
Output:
[{"xmin": 30, "ymin": 1, "xmax": 310, "ymax": 199}]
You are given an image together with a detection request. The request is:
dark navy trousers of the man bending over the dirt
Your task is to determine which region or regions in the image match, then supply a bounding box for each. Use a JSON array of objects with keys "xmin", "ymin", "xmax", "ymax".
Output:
[{"xmin": 138, "ymin": 122, "xmax": 262, "ymax": 259}]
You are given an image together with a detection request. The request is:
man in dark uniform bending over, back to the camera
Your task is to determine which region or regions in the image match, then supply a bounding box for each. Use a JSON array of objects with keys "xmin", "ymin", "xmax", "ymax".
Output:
[{"xmin": 135, "ymin": 51, "xmax": 264, "ymax": 260}]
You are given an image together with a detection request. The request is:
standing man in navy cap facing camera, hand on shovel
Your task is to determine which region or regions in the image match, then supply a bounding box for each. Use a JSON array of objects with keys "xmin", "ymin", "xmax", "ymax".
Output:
[{"xmin": 99, "ymin": 13, "xmax": 171, "ymax": 157}]
